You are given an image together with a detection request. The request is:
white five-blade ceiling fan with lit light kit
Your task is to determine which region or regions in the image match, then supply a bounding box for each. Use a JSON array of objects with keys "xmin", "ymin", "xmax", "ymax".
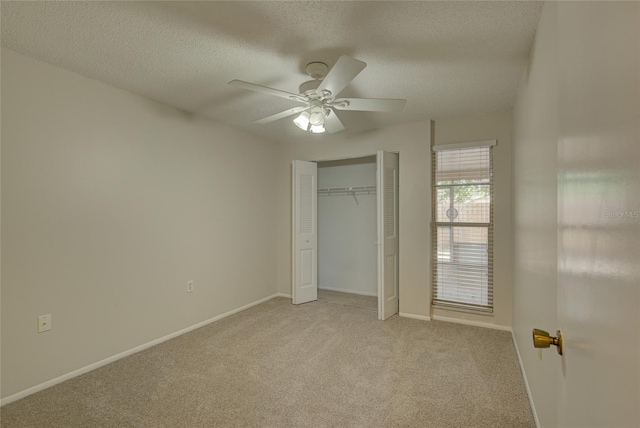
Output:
[{"xmin": 229, "ymin": 55, "xmax": 407, "ymax": 134}]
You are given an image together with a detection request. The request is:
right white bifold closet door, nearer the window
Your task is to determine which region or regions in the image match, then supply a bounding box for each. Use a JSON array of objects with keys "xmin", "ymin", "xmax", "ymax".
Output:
[{"xmin": 377, "ymin": 151, "xmax": 398, "ymax": 320}]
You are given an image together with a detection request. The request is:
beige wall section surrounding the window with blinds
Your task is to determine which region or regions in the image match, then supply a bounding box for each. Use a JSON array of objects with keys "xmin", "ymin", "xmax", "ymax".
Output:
[{"xmin": 433, "ymin": 111, "xmax": 512, "ymax": 327}]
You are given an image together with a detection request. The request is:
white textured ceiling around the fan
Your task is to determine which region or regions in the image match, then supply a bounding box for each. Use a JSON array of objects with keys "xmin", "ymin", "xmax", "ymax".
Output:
[{"xmin": 1, "ymin": 1, "xmax": 541, "ymax": 141}]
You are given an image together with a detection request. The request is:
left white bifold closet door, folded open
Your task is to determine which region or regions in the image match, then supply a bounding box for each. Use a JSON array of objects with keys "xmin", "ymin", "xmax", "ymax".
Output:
[{"xmin": 291, "ymin": 161, "xmax": 318, "ymax": 305}]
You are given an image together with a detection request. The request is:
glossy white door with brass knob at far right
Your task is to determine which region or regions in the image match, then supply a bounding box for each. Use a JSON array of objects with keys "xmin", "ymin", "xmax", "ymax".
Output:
[{"xmin": 557, "ymin": 2, "xmax": 640, "ymax": 427}]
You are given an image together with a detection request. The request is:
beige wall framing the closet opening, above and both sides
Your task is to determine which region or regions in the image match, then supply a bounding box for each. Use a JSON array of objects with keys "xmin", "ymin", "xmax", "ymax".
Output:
[{"xmin": 276, "ymin": 121, "xmax": 431, "ymax": 317}]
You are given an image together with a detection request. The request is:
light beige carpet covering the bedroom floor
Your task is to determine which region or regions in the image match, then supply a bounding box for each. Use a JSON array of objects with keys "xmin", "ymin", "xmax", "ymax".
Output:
[{"xmin": 1, "ymin": 298, "xmax": 535, "ymax": 428}]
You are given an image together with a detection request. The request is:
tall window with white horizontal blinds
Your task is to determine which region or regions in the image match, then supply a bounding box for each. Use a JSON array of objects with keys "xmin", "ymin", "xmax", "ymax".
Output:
[{"xmin": 432, "ymin": 141, "xmax": 495, "ymax": 313}]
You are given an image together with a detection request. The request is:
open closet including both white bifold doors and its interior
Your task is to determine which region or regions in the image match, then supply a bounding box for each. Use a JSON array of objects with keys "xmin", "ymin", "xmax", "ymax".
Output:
[{"xmin": 291, "ymin": 151, "xmax": 400, "ymax": 320}]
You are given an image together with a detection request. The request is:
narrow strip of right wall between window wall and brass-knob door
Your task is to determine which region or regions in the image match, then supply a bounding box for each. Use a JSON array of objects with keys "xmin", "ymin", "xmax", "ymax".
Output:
[{"xmin": 513, "ymin": 3, "xmax": 558, "ymax": 427}]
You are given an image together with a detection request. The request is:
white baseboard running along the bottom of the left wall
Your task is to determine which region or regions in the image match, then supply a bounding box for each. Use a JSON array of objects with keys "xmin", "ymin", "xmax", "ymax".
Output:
[{"xmin": 0, "ymin": 293, "xmax": 282, "ymax": 407}]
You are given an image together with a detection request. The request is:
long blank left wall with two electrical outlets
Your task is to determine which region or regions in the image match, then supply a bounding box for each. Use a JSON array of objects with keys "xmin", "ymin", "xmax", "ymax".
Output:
[{"xmin": 2, "ymin": 49, "xmax": 277, "ymax": 397}]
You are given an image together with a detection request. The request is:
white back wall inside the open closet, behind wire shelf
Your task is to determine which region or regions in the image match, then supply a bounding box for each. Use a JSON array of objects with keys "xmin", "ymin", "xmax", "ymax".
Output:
[{"xmin": 318, "ymin": 159, "xmax": 378, "ymax": 296}]
